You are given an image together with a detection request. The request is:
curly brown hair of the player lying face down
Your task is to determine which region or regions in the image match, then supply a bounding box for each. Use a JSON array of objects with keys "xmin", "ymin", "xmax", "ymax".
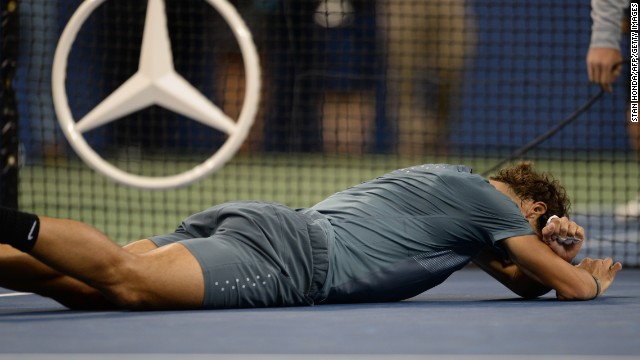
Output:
[{"xmin": 490, "ymin": 162, "xmax": 571, "ymax": 232}]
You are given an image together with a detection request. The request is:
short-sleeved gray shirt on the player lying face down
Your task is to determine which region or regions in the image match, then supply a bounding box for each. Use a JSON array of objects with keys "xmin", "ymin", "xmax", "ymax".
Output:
[{"xmin": 312, "ymin": 164, "xmax": 535, "ymax": 302}]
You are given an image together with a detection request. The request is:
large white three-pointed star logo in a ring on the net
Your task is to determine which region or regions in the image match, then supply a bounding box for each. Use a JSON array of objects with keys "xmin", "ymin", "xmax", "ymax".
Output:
[{"xmin": 52, "ymin": 0, "xmax": 260, "ymax": 189}]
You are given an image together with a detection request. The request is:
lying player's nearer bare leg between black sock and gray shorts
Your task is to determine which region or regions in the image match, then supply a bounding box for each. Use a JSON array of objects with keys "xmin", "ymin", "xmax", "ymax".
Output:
[{"xmin": 3, "ymin": 211, "xmax": 204, "ymax": 309}]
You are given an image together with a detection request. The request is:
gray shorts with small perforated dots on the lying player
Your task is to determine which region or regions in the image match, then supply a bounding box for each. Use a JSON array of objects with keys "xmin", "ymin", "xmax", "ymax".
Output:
[{"xmin": 150, "ymin": 201, "xmax": 329, "ymax": 309}]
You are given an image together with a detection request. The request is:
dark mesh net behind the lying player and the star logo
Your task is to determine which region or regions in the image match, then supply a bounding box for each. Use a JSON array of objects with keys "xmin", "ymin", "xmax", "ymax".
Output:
[{"xmin": 0, "ymin": 0, "xmax": 640, "ymax": 266}]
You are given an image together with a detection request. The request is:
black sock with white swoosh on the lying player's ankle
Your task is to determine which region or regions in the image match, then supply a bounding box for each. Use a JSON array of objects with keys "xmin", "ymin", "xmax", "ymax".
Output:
[{"xmin": 0, "ymin": 207, "xmax": 40, "ymax": 252}]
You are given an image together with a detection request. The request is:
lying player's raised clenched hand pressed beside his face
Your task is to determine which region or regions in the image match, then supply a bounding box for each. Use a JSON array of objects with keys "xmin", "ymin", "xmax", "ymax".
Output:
[{"xmin": 542, "ymin": 217, "xmax": 584, "ymax": 262}]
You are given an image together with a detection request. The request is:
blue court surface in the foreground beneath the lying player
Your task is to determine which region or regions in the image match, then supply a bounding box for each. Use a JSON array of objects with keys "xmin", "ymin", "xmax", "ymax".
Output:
[{"xmin": 0, "ymin": 268, "xmax": 640, "ymax": 359}]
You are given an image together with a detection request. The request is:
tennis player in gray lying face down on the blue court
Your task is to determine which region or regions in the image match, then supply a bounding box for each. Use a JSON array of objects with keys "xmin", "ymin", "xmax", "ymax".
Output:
[{"xmin": 0, "ymin": 163, "xmax": 622, "ymax": 309}]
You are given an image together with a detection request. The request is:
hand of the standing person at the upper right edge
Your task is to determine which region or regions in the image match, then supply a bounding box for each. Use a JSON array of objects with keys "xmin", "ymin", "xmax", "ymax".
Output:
[{"xmin": 587, "ymin": 48, "xmax": 622, "ymax": 92}]
